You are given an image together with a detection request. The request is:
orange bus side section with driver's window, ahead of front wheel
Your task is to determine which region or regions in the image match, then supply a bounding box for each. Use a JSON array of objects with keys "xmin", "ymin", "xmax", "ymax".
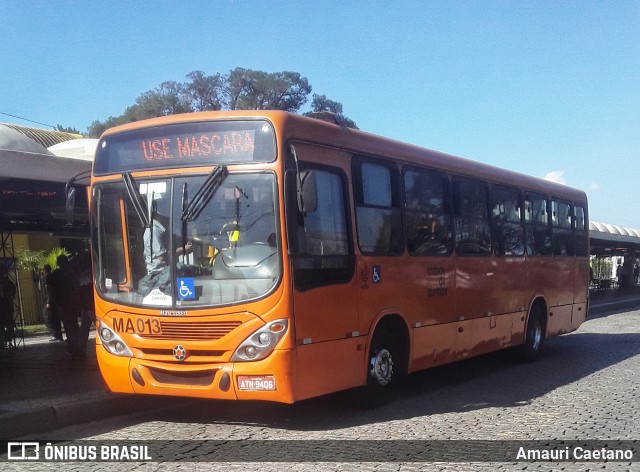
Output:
[{"xmin": 285, "ymin": 143, "xmax": 364, "ymax": 399}]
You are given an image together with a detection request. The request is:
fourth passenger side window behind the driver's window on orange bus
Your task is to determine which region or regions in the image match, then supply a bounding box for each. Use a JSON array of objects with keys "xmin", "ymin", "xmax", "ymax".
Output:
[{"xmin": 491, "ymin": 185, "xmax": 524, "ymax": 257}]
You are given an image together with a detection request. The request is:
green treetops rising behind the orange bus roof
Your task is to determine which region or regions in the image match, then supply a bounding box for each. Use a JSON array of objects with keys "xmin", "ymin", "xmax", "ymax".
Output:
[{"xmin": 87, "ymin": 67, "xmax": 357, "ymax": 138}]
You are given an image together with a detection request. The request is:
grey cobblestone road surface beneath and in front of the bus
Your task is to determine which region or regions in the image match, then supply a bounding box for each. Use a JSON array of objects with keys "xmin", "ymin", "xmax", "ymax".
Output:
[{"xmin": 5, "ymin": 311, "xmax": 640, "ymax": 471}]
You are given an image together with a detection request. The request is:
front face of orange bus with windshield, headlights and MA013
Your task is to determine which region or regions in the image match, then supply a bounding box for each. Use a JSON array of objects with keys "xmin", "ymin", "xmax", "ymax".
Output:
[{"xmin": 91, "ymin": 117, "xmax": 293, "ymax": 402}]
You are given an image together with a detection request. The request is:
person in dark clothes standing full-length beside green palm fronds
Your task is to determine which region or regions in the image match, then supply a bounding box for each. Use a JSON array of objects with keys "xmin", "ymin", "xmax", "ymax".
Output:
[{"xmin": 50, "ymin": 254, "xmax": 84, "ymax": 358}]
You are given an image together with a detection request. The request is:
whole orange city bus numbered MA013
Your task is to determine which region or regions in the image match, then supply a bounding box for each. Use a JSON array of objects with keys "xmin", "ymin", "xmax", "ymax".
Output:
[{"xmin": 90, "ymin": 111, "xmax": 589, "ymax": 403}]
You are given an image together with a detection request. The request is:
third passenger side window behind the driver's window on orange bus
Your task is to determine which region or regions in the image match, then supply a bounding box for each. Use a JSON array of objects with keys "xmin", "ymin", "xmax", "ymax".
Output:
[{"xmin": 453, "ymin": 179, "xmax": 491, "ymax": 255}]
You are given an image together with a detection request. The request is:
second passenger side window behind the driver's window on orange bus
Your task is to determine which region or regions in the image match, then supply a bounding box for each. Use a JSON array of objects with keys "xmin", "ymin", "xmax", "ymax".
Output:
[{"xmin": 404, "ymin": 169, "xmax": 453, "ymax": 256}]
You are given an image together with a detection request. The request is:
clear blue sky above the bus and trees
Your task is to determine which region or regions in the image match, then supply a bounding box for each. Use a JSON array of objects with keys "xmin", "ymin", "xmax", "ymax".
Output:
[{"xmin": 0, "ymin": 0, "xmax": 640, "ymax": 229}]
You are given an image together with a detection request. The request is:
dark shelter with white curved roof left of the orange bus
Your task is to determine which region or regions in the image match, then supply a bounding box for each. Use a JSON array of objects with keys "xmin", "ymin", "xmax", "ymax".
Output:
[{"xmin": 0, "ymin": 124, "xmax": 97, "ymax": 343}]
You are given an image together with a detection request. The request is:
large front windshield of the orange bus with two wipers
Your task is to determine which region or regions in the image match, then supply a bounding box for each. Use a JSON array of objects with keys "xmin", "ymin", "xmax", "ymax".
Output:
[{"xmin": 92, "ymin": 168, "xmax": 281, "ymax": 308}]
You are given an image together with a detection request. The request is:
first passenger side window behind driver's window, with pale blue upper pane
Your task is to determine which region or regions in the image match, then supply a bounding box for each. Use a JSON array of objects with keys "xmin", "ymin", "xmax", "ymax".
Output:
[{"xmin": 354, "ymin": 159, "xmax": 404, "ymax": 255}]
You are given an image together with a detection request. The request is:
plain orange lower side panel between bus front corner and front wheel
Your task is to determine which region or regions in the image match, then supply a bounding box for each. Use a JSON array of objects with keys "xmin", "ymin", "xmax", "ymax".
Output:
[{"xmin": 293, "ymin": 336, "xmax": 367, "ymax": 401}]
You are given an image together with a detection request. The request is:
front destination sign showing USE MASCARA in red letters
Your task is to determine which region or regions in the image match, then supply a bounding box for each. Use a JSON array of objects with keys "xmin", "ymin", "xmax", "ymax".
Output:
[{"xmin": 94, "ymin": 121, "xmax": 275, "ymax": 175}]
